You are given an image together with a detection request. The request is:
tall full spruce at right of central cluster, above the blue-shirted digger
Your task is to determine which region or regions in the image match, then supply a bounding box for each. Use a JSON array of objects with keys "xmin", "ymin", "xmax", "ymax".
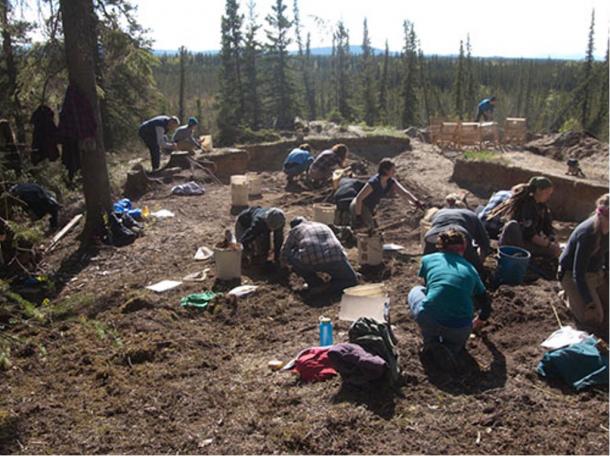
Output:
[{"xmin": 265, "ymin": 0, "xmax": 296, "ymax": 129}]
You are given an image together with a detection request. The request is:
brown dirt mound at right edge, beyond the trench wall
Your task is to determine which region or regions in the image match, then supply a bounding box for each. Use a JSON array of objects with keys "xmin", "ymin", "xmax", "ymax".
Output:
[{"xmin": 525, "ymin": 131, "xmax": 608, "ymax": 161}]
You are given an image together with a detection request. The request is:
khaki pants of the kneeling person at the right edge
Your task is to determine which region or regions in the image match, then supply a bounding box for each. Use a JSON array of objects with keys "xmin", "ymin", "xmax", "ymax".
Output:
[{"xmin": 561, "ymin": 271, "xmax": 608, "ymax": 325}]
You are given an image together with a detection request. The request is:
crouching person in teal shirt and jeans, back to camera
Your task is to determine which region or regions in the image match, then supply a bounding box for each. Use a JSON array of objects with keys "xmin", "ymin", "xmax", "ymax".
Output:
[{"xmin": 407, "ymin": 229, "xmax": 491, "ymax": 368}]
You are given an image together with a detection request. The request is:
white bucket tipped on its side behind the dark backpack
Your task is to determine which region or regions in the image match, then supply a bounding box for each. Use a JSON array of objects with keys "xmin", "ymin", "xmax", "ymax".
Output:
[{"xmin": 339, "ymin": 283, "xmax": 390, "ymax": 322}]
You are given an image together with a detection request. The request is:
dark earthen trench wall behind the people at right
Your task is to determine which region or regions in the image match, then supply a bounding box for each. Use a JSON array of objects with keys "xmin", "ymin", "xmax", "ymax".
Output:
[{"xmin": 451, "ymin": 160, "xmax": 608, "ymax": 222}]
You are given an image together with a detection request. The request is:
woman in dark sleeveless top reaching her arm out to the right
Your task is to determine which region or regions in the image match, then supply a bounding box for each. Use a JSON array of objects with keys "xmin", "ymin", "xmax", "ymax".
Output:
[{"xmin": 350, "ymin": 158, "xmax": 423, "ymax": 229}]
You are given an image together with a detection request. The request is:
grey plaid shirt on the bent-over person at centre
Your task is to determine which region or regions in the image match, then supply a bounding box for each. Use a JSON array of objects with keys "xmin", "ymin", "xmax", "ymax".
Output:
[{"xmin": 280, "ymin": 222, "xmax": 347, "ymax": 265}]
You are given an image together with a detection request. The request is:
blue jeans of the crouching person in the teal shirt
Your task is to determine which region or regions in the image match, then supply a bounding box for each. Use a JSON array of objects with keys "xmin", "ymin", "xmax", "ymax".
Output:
[{"xmin": 407, "ymin": 286, "xmax": 472, "ymax": 353}]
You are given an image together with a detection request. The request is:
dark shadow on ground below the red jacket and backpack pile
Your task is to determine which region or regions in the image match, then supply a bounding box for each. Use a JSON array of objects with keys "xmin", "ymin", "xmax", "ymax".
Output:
[{"xmin": 332, "ymin": 382, "xmax": 401, "ymax": 420}]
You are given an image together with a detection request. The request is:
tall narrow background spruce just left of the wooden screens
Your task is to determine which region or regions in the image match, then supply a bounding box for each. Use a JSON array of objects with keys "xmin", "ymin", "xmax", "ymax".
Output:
[{"xmin": 401, "ymin": 21, "xmax": 418, "ymax": 128}]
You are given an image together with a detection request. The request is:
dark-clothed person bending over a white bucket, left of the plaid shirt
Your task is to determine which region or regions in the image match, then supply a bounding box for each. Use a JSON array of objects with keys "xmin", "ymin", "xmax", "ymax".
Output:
[{"xmin": 235, "ymin": 206, "xmax": 286, "ymax": 264}]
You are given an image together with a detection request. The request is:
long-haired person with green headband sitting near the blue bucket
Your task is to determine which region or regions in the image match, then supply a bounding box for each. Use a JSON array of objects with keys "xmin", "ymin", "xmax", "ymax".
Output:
[{"xmin": 487, "ymin": 176, "xmax": 561, "ymax": 258}]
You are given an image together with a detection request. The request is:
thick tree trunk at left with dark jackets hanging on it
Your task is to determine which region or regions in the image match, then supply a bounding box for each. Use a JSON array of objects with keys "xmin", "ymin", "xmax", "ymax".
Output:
[{"xmin": 60, "ymin": 0, "xmax": 111, "ymax": 242}]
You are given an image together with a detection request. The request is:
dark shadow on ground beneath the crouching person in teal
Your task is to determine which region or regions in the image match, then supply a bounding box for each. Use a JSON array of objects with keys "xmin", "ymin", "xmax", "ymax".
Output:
[{"xmin": 420, "ymin": 335, "xmax": 506, "ymax": 395}]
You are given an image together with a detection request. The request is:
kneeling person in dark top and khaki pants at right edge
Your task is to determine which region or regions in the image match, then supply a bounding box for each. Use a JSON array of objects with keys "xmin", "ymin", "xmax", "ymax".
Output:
[{"xmin": 559, "ymin": 193, "xmax": 608, "ymax": 330}]
